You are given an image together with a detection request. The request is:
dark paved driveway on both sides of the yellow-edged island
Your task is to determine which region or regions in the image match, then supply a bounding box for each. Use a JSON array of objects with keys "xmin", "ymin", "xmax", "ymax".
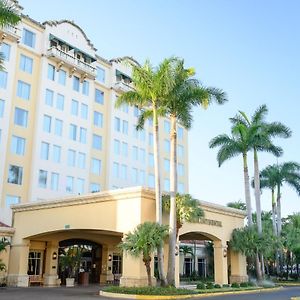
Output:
[{"xmin": 0, "ymin": 285, "xmax": 300, "ymax": 300}]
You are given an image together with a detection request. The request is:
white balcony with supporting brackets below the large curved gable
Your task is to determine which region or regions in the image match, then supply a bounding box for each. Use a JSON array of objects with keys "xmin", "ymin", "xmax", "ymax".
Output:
[{"xmin": 47, "ymin": 47, "xmax": 96, "ymax": 79}]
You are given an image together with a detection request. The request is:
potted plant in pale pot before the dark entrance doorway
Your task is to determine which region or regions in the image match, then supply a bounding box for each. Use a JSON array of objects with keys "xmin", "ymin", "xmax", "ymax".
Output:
[{"xmin": 59, "ymin": 246, "xmax": 81, "ymax": 287}]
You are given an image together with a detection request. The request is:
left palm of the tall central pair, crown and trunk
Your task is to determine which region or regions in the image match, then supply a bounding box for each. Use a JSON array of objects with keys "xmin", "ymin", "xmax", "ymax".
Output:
[{"xmin": 115, "ymin": 58, "xmax": 174, "ymax": 285}]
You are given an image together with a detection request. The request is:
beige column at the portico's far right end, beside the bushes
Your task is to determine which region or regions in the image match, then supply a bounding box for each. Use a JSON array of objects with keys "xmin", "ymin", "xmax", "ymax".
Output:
[{"xmin": 229, "ymin": 250, "xmax": 248, "ymax": 283}]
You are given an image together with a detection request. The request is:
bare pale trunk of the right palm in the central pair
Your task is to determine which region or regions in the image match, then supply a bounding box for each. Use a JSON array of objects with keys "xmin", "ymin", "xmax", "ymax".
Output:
[{"xmin": 167, "ymin": 115, "xmax": 177, "ymax": 285}]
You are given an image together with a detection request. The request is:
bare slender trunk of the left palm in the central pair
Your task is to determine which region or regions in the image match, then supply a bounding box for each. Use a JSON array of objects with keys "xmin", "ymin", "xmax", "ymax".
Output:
[{"xmin": 153, "ymin": 106, "xmax": 167, "ymax": 286}]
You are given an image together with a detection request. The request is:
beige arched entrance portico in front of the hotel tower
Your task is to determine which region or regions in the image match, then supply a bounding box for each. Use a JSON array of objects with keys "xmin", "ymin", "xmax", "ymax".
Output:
[{"xmin": 3, "ymin": 187, "xmax": 247, "ymax": 286}]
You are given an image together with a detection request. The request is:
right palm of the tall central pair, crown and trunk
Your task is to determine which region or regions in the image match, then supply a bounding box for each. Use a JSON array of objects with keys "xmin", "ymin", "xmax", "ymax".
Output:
[{"xmin": 163, "ymin": 59, "xmax": 226, "ymax": 285}]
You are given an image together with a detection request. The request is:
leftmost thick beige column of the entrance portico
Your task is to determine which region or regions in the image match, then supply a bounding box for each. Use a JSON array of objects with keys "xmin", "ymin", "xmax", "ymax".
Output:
[{"xmin": 7, "ymin": 239, "xmax": 30, "ymax": 287}]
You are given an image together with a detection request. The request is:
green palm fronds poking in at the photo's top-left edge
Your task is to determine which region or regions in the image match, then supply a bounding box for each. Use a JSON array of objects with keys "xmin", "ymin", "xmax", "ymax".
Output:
[{"xmin": 0, "ymin": 0, "xmax": 21, "ymax": 70}]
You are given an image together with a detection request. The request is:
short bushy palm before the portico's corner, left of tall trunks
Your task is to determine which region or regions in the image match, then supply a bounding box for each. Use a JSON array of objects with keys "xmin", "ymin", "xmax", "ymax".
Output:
[{"xmin": 119, "ymin": 222, "xmax": 168, "ymax": 286}]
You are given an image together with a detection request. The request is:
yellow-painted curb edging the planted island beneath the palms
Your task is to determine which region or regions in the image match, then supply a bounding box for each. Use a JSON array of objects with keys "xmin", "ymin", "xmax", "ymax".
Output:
[{"xmin": 99, "ymin": 287, "xmax": 282, "ymax": 300}]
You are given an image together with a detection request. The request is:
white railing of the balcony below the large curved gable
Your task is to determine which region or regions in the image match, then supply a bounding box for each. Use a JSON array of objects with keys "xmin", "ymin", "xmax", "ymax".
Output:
[{"xmin": 47, "ymin": 47, "xmax": 96, "ymax": 78}]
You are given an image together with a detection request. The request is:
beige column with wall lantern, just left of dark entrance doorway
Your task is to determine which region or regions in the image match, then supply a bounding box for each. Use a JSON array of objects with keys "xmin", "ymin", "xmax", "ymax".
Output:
[{"xmin": 44, "ymin": 242, "xmax": 60, "ymax": 286}]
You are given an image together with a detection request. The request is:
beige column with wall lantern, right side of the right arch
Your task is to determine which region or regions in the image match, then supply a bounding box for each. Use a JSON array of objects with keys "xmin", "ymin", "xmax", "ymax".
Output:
[{"xmin": 214, "ymin": 241, "xmax": 228, "ymax": 285}]
